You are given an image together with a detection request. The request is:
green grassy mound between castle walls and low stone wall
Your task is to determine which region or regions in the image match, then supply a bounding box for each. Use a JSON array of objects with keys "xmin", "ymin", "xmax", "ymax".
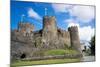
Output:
[{"xmin": 44, "ymin": 49, "xmax": 78, "ymax": 55}]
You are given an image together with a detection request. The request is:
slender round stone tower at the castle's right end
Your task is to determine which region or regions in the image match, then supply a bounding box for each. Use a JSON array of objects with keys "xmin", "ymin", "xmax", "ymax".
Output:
[{"xmin": 68, "ymin": 26, "xmax": 81, "ymax": 53}]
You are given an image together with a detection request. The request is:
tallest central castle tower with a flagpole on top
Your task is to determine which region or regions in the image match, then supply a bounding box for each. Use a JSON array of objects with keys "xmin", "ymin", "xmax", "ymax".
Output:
[{"xmin": 42, "ymin": 16, "xmax": 57, "ymax": 43}]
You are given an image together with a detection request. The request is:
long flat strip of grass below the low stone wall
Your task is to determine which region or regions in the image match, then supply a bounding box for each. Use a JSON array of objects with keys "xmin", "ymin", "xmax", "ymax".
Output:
[{"xmin": 11, "ymin": 59, "xmax": 80, "ymax": 67}]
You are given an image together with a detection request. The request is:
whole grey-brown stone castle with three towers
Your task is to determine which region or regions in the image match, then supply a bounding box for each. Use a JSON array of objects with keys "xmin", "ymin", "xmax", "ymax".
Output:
[{"xmin": 11, "ymin": 16, "xmax": 81, "ymax": 58}]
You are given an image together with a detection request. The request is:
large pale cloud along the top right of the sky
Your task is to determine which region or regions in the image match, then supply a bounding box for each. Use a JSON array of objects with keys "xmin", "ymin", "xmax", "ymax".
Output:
[{"xmin": 52, "ymin": 4, "xmax": 95, "ymax": 23}]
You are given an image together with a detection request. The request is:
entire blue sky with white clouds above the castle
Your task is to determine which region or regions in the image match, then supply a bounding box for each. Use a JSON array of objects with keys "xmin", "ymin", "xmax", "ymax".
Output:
[{"xmin": 11, "ymin": 1, "xmax": 95, "ymax": 41}]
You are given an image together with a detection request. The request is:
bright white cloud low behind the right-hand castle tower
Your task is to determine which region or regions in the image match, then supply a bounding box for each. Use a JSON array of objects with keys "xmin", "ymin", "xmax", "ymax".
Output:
[{"xmin": 67, "ymin": 19, "xmax": 95, "ymax": 41}]
